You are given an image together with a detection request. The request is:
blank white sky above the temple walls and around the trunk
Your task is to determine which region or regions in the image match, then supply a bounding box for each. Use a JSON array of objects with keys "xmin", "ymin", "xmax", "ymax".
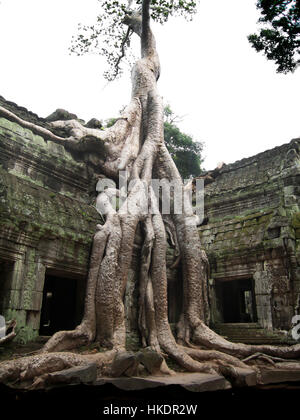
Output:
[{"xmin": 0, "ymin": 0, "xmax": 300, "ymax": 169}]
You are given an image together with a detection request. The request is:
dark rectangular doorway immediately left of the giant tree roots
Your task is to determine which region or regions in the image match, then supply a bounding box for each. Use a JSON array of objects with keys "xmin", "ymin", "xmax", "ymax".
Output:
[{"xmin": 39, "ymin": 275, "xmax": 83, "ymax": 335}]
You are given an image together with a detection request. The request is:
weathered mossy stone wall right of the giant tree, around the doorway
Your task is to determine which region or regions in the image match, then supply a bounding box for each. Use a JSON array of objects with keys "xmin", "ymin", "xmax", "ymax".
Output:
[{"xmin": 199, "ymin": 139, "xmax": 300, "ymax": 342}]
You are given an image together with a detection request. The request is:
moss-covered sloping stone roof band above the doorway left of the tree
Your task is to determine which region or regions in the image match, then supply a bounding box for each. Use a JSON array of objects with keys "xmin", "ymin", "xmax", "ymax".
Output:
[{"xmin": 0, "ymin": 169, "xmax": 101, "ymax": 244}]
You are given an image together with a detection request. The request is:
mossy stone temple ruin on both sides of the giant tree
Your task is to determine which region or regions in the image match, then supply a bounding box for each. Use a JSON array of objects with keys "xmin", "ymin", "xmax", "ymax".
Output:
[{"xmin": 0, "ymin": 98, "xmax": 300, "ymax": 343}]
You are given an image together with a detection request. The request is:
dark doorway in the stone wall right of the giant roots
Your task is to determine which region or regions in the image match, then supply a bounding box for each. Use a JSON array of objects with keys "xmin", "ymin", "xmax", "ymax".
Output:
[{"xmin": 217, "ymin": 279, "xmax": 257, "ymax": 323}]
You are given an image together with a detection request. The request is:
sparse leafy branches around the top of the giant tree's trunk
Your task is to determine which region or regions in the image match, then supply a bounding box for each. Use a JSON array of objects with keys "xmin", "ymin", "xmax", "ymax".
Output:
[{"xmin": 70, "ymin": 0, "xmax": 198, "ymax": 80}]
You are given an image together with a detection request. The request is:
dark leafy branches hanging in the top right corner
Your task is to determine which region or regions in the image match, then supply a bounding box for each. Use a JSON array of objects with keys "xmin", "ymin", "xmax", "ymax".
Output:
[{"xmin": 248, "ymin": 0, "xmax": 300, "ymax": 73}]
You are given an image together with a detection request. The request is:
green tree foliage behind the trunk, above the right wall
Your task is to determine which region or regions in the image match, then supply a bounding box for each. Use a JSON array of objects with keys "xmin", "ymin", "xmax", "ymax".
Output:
[{"xmin": 164, "ymin": 105, "xmax": 203, "ymax": 179}]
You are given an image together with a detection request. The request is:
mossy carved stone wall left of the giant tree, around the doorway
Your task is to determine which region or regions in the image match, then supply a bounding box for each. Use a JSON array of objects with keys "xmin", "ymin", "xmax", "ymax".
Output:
[{"xmin": 0, "ymin": 100, "xmax": 101, "ymax": 342}]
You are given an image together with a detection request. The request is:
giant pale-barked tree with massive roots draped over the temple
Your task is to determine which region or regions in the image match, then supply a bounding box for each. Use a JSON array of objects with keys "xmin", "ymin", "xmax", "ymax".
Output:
[{"xmin": 0, "ymin": 0, "xmax": 300, "ymax": 387}]
